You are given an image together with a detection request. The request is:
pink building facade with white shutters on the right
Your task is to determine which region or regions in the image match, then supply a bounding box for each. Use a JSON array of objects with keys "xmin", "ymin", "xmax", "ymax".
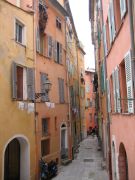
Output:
[{"xmin": 91, "ymin": 0, "xmax": 135, "ymax": 180}]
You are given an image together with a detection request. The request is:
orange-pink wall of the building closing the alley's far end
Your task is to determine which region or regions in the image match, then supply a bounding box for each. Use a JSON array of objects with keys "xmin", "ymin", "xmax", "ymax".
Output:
[{"xmin": 85, "ymin": 71, "xmax": 95, "ymax": 130}]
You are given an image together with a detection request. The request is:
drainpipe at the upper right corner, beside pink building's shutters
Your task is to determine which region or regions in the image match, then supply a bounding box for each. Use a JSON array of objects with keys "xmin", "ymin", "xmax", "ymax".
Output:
[{"xmin": 128, "ymin": 0, "xmax": 135, "ymax": 87}]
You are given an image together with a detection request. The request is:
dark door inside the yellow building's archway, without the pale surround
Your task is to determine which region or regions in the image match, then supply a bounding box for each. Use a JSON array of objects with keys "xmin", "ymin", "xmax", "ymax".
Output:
[{"xmin": 4, "ymin": 138, "xmax": 20, "ymax": 180}]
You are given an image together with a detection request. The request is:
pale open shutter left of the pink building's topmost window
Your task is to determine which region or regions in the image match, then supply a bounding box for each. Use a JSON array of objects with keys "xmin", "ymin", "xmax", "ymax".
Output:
[{"xmin": 110, "ymin": 0, "xmax": 115, "ymax": 40}]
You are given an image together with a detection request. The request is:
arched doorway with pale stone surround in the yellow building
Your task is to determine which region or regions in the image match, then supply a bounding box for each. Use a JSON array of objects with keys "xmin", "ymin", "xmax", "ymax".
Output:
[{"xmin": 2, "ymin": 135, "xmax": 30, "ymax": 180}]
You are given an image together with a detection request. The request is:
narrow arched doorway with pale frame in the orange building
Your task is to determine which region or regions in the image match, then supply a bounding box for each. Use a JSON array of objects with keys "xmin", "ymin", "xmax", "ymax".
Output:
[{"xmin": 61, "ymin": 124, "xmax": 68, "ymax": 159}]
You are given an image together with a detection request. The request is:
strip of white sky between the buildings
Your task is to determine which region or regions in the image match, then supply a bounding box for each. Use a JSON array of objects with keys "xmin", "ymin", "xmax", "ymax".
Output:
[{"xmin": 69, "ymin": 0, "xmax": 95, "ymax": 69}]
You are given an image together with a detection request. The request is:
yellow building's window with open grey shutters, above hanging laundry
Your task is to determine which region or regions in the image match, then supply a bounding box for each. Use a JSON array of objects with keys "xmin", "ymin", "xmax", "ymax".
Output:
[{"xmin": 12, "ymin": 62, "xmax": 35, "ymax": 100}]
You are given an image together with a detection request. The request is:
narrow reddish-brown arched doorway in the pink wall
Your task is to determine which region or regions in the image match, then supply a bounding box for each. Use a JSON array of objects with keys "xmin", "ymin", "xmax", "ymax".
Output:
[{"xmin": 119, "ymin": 143, "xmax": 128, "ymax": 180}]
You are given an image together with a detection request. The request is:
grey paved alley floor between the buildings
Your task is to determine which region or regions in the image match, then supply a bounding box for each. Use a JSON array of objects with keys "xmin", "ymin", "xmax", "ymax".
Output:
[{"xmin": 54, "ymin": 136, "xmax": 109, "ymax": 180}]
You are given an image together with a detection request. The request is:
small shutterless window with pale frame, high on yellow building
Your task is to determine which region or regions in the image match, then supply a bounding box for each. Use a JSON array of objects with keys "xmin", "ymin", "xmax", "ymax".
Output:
[{"xmin": 15, "ymin": 20, "xmax": 25, "ymax": 45}]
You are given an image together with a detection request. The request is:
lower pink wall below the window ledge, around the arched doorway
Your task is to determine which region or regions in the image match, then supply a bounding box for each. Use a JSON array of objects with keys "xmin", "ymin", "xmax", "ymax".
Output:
[{"xmin": 111, "ymin": 115, "xmax": 135, "ymax": 180}]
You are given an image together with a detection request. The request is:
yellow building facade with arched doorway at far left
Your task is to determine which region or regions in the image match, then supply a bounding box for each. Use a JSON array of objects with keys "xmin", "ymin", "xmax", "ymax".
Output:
[{"xmin": 0, "ymin": 0, "xmax": 35, "ymax": 180}]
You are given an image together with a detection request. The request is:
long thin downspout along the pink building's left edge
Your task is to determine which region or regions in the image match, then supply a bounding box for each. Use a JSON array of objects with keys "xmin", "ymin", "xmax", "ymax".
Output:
[{"xmin": 101, "ymin": 0, "xmax": 112, "ymax": 180}]
